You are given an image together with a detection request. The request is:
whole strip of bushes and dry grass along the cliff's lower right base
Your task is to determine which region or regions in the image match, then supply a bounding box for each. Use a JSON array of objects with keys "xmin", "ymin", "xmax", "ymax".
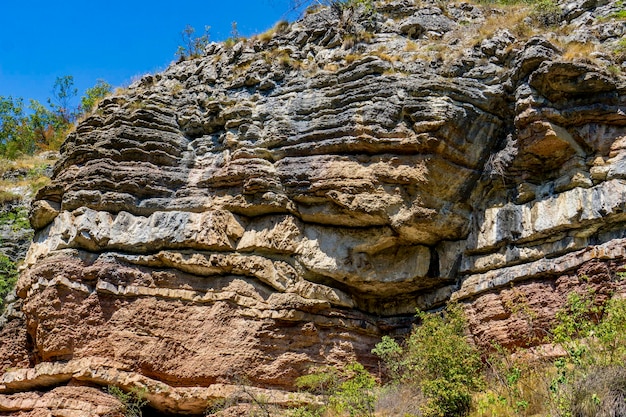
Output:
[{"xmin": 282, "ymin": 290, "xmax": 626, "ymax": 417}]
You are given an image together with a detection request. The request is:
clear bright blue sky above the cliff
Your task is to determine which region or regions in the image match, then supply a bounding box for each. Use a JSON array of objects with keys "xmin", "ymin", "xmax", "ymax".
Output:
[{"xmin": 0, "ymin": 0, "xmax": 304, "ymax": 104}]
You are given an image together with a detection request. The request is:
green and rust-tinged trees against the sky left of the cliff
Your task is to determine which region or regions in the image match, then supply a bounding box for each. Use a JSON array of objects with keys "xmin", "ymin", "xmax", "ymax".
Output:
[{"xmin": 0, "ymin": 75, "xmax": 111, "ymax": 159}]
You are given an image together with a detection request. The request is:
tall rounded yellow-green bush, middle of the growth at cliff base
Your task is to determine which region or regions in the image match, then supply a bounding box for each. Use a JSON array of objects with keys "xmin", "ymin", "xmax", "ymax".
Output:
[{"xmin": 373, "ymin": 304, "xmax": 483, "ymax": 417}]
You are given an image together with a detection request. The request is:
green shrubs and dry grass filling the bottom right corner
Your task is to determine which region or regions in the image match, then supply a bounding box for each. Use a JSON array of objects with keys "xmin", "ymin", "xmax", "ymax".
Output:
[{"xmin": 476, "ymin": 290, "xmax": 626, "ymax": 417}]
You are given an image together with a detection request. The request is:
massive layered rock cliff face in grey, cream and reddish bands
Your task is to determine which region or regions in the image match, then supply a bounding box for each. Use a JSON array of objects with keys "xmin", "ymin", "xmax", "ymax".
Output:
[{"xmin": 0, "ymin": 1, "xmax": 626, "ymax": 415}]
